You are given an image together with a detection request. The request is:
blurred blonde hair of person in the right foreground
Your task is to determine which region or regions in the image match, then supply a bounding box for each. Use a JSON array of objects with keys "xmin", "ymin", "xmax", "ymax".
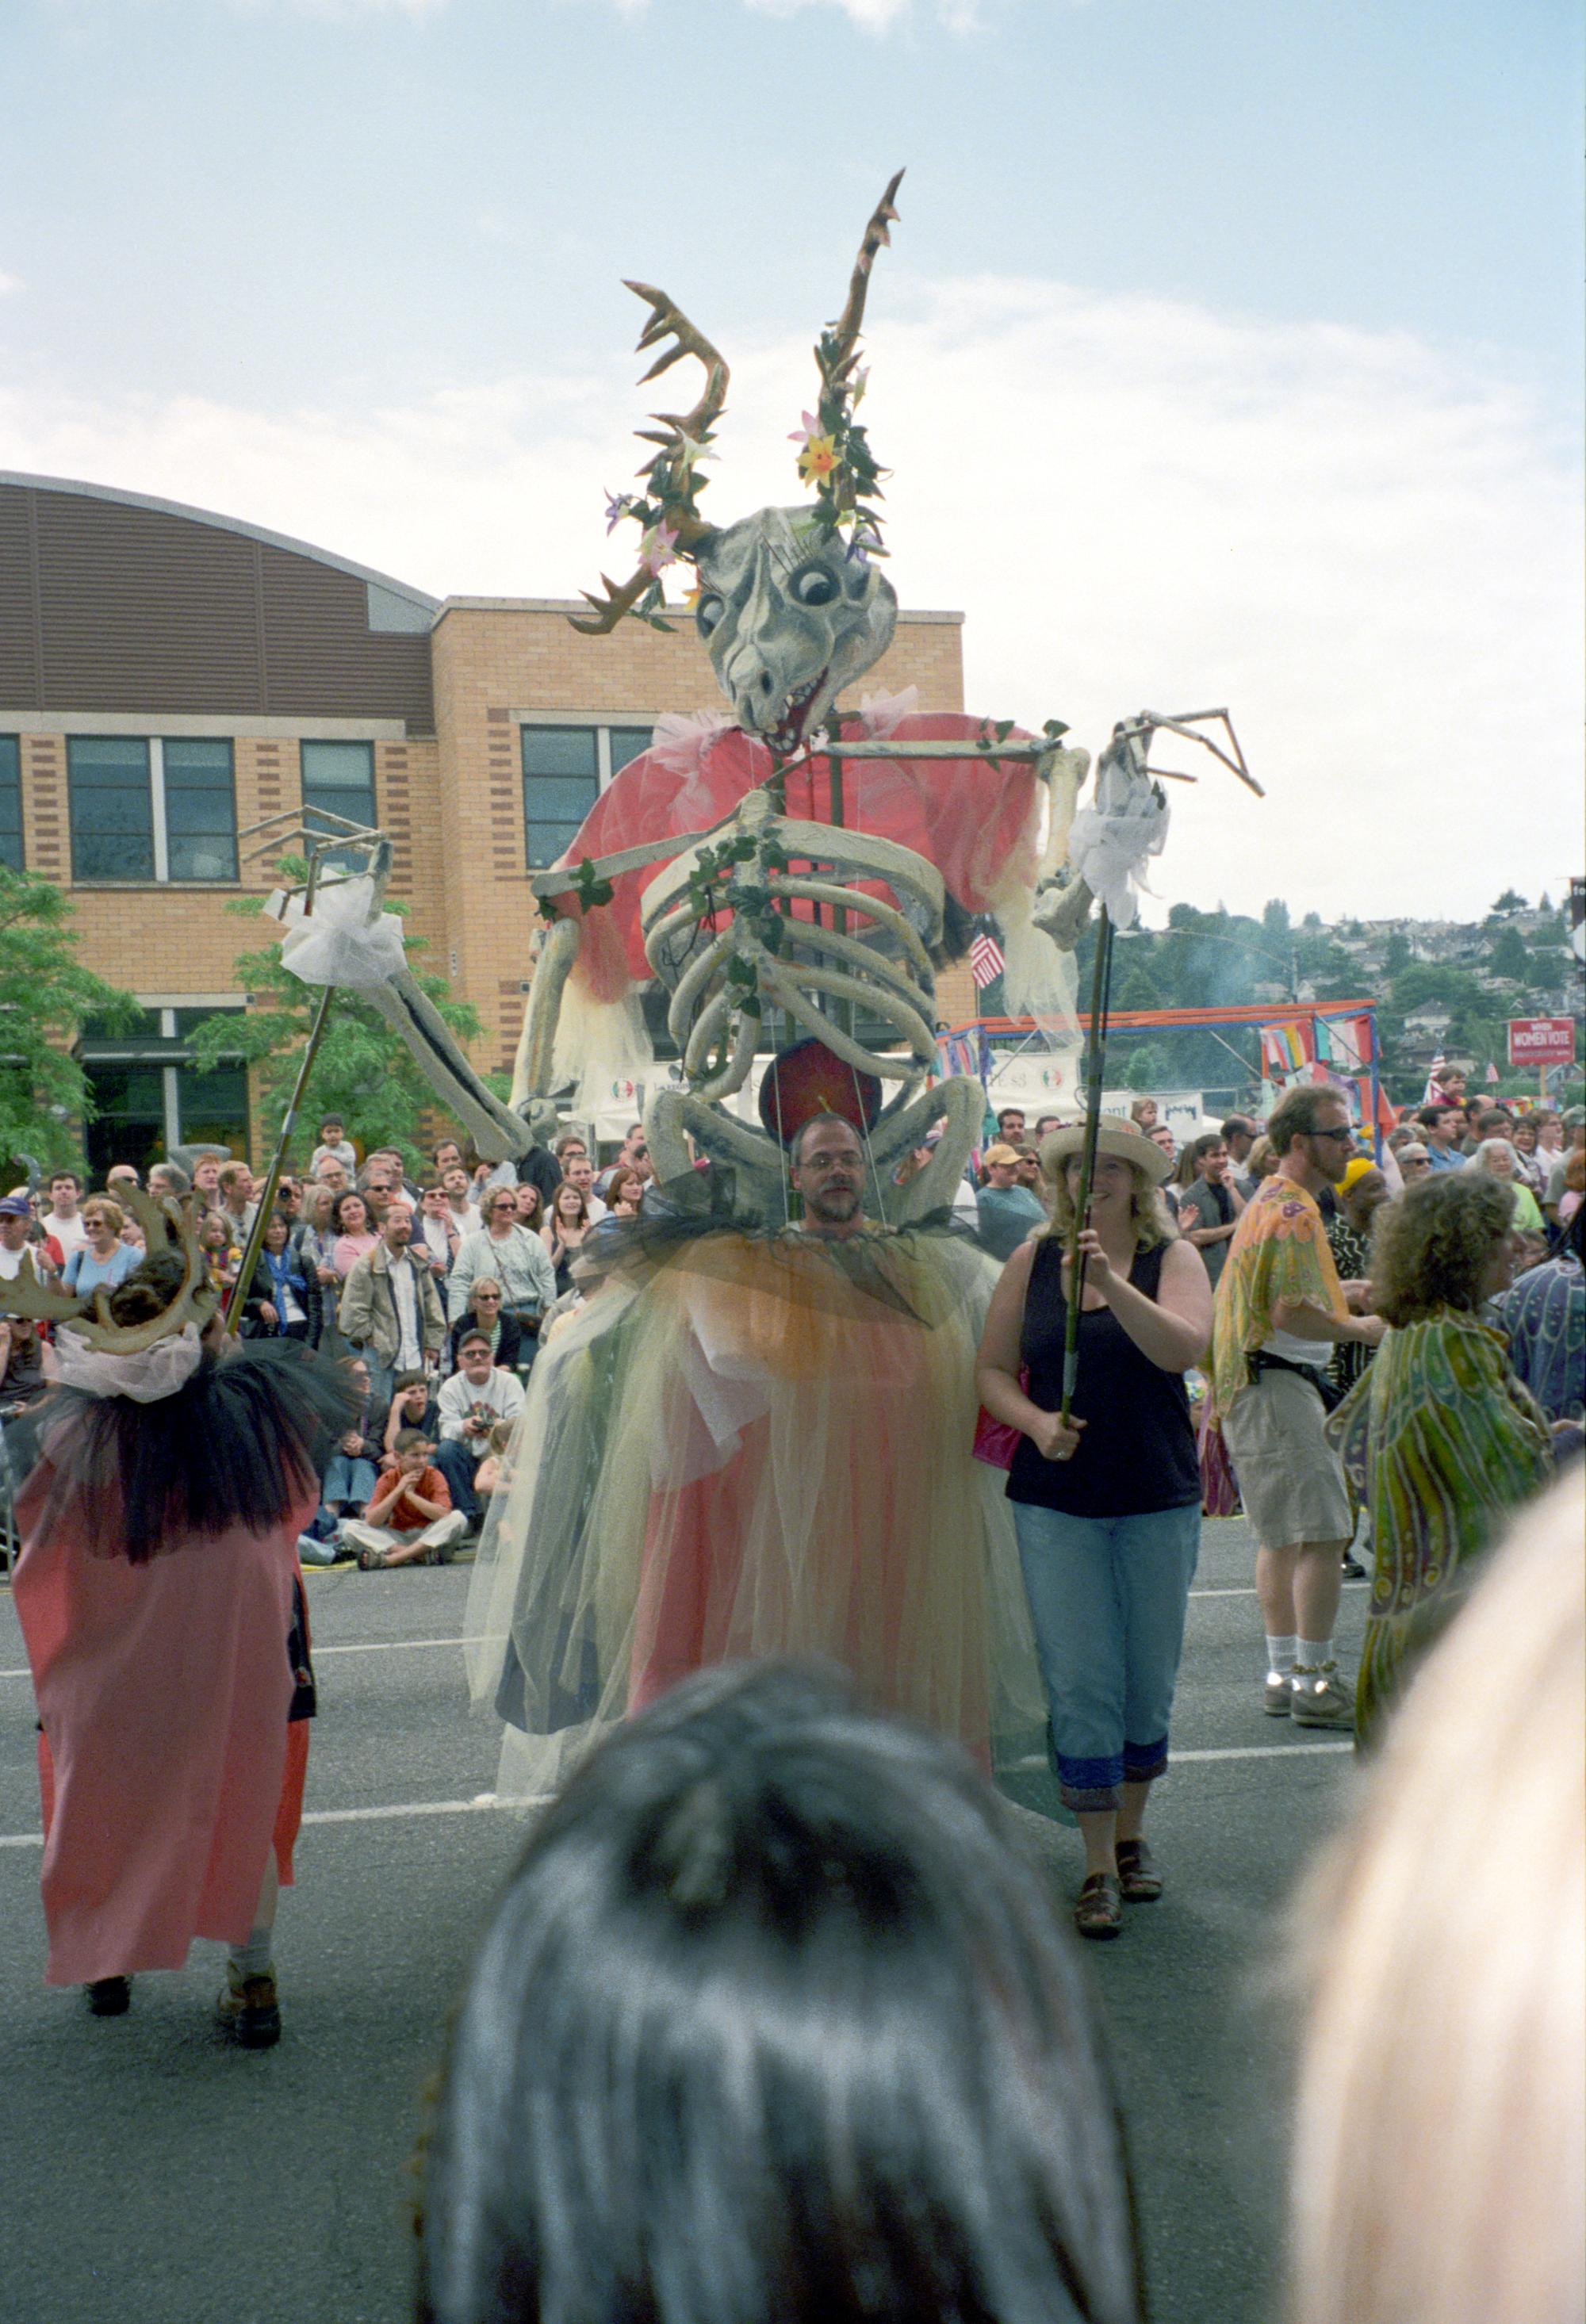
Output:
[{"xmin": 1291, "ymin": 1462, "xmax": 1586, "ymax": 2324}]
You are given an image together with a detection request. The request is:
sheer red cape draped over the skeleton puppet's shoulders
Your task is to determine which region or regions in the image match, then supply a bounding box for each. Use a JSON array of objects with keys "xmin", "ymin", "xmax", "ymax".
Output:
[{"xmin": 544, "ymin": 711, "xmax": 1035, "ymax": 1001}]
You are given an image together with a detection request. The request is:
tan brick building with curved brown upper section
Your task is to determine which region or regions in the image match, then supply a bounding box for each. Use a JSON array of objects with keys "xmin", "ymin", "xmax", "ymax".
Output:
[{"xmin": 0, "ymin": 474, "xmax": 972, "ymax": 1162}]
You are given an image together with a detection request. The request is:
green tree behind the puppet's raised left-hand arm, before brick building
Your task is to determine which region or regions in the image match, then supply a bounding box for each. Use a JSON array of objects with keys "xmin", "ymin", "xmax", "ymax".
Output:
[{"xmin": 190, "ymin": 860, "xmax": 479, "ymax": 1164}]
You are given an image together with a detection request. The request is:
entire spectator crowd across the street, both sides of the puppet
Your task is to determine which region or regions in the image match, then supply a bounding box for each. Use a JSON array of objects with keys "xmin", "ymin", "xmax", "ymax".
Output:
[{"xmin": 0, "ymin": 1097, "xmax": 1586, "ymax": 1564}]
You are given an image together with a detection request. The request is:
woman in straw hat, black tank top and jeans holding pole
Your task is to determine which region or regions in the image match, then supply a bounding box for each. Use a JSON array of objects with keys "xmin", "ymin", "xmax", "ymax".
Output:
[{"xmin": 979, "ymin": 1116, "xmax": 1212, "ymax": 1938}]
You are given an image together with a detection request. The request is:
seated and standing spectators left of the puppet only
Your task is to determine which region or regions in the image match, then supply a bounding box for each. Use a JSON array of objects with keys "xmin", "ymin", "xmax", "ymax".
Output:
[{"xmin": 0, "ymin": 1116, "xmax": 651, "ymax": 1568}]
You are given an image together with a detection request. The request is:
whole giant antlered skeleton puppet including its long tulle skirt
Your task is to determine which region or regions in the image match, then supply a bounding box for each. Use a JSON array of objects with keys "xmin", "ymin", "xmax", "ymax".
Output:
[{"xmin": 439, "ymin": 179, "xmax": 1255, "ymax": 1797}]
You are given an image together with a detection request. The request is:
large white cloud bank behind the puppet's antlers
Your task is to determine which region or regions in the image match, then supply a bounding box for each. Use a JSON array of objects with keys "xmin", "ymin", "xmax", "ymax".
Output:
[{"xmin": 0, "ymin": 270, "xmax": 1581, "ymax": 916}]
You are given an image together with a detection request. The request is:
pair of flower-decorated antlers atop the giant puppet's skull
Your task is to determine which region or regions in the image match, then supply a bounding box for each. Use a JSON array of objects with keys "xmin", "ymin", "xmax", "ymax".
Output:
[{"xmin": 569, "ymin": 170, "xmax": 902, "ymax": 637}]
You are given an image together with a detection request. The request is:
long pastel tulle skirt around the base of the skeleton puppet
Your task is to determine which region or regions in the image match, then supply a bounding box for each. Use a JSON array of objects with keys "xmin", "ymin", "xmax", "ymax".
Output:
[{"xmin": 467, "ymin": 1227, "xmax": 1044, "ymax": 1797}]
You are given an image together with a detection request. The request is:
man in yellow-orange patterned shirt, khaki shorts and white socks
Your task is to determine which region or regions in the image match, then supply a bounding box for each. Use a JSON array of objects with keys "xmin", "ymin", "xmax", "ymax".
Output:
[{"xmin": 1212, "ymin": 1088, "xmax": 1386, "ymax": 1727}]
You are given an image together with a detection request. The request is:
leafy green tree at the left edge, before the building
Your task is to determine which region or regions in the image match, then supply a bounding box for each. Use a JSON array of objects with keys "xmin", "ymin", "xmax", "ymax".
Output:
[{"xmin": 0, "ymin": 864, "xmax": 137, "ymax": 1183}]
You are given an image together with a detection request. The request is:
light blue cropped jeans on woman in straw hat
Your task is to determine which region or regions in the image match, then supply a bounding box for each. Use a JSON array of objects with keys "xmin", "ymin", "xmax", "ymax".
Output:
[{"xmin": 1014, "ymin": 1501, "xmax": 1200, "ymax": 1815}]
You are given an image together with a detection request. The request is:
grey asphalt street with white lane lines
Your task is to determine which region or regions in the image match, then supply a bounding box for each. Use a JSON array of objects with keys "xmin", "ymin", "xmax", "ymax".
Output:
[{"xmin": 0, "ymin": 1520, "xmax": 1365, "ymax": 2324}]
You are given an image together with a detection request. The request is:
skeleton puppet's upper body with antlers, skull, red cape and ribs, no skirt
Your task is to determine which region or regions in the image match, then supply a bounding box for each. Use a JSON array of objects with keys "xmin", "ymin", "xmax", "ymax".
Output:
[{"xmin": 514, "ymin": 179, "xmax": 1090, "ymax": 1223}]
